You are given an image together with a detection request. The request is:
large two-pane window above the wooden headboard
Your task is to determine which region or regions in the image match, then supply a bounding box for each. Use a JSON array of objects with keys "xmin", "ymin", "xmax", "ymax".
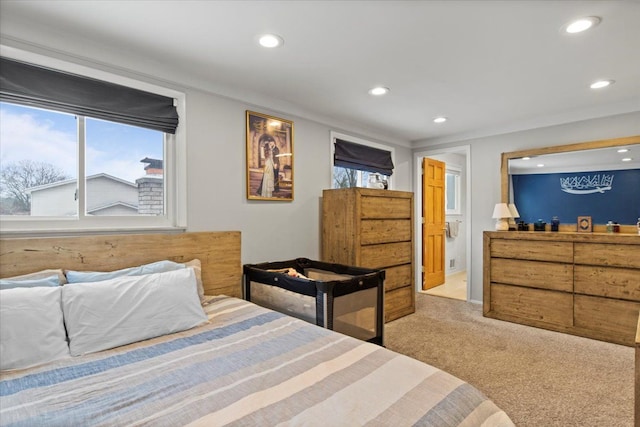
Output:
[{"xmin": 0, "ymin": 54, "xmax": 186, "ymax": 233}]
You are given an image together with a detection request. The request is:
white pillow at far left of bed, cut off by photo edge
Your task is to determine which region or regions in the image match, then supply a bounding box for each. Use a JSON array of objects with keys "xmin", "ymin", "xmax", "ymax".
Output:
[{"xmin": 0, "ymin": 286, "xmax": 69, "ymax": 370}]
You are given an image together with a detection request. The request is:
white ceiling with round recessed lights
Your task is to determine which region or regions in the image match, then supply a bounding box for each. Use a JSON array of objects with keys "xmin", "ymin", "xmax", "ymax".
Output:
[{"xmin": 0, "ymin": 0, "xmax": 640, "ymax": 145}]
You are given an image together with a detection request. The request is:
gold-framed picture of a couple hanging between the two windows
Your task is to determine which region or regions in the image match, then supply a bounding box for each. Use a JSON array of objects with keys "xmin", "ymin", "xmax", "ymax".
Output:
[{"xmin": 247, "ymin": 111, "xmax": 293, "ymax": 201}]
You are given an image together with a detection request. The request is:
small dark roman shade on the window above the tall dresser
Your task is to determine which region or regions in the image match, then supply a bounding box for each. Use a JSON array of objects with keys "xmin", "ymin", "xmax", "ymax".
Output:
[{"xmin": 333, "ymin": 138, "xmax": 393, "ymax": 176}]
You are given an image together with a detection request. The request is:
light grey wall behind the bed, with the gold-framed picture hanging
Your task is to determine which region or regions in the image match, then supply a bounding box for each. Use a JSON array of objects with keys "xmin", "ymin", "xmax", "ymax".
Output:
[{"xmin": 2, "ymin": 37, "xmax": 412, "ymax": 278}]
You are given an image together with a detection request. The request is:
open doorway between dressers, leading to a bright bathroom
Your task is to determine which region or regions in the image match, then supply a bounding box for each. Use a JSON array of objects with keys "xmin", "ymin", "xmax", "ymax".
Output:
[{"xmin": 414, "ymin": 146, "xmax": 471, "ymax": 301}]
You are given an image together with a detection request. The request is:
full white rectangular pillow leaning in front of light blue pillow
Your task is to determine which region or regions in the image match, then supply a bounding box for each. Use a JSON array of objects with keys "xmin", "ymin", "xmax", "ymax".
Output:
[{"xmin": 62, "ymin": 268, "xmax": 207, "ymax": 356}]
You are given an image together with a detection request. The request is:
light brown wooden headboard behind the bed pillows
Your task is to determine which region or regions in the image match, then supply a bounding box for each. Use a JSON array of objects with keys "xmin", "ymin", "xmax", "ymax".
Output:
[{"xmin": 0, "ymin": 231, "xmax": 242, "ymax": 297}]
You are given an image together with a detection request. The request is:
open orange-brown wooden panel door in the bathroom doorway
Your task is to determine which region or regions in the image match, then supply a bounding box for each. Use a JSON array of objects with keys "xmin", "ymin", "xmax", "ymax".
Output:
[{"xmin": 422, "ymin": 157, "xmax": 445, "ymax": 290}]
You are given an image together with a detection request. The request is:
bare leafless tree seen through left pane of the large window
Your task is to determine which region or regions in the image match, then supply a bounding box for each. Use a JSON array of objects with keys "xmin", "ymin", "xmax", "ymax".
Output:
[{"xmin": 0, "ymin": 160, "xmax": 70, "ymax": 215}]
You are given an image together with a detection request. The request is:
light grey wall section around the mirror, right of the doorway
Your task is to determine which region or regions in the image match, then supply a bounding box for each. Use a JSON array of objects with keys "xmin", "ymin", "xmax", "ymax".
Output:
[{"xmin": 414, "ymin": 111, "xmax": 640, "ymax": 302}]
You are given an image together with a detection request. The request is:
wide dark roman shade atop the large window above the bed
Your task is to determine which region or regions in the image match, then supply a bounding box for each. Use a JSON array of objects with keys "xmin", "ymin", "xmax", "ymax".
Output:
[{"xmin": 0, "ymin": 58, "xmax": 178, "ymax": 134}]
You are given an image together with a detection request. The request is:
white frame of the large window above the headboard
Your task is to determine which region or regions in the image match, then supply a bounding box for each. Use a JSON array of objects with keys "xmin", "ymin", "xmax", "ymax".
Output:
[{"xmin": 0, "ymin": 45, "xmax": 187, "ymax": 236}]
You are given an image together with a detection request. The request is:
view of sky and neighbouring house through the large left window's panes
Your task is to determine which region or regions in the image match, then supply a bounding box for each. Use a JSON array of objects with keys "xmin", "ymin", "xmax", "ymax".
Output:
[{"xmin": 0, "ymin": 102, "xmax": 165, "ymax": 217}]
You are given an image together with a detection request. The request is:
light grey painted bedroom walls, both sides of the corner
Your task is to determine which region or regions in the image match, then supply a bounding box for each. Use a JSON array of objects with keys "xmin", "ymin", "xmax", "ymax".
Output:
[{"xmin": 5, "ymin": 37, "xmax": 640, "ymax": 301}]
